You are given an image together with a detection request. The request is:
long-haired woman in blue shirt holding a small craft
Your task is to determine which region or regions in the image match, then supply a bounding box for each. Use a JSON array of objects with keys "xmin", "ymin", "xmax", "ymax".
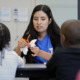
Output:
[{"xmin": 16, "ymin": 5, "xmax": 60, "ymax": 63}]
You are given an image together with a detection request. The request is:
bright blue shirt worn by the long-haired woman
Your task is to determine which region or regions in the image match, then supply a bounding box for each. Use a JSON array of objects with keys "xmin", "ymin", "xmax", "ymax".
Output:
[{"xmin": 35, "ymin": 34, "xmax": 53, "ymax": 63}]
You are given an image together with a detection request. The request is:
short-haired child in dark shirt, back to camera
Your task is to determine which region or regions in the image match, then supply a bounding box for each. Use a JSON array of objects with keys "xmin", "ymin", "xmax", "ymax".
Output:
[{"xmin": 46, "ymin": 20, "xmax": 80, "ymax": 80}]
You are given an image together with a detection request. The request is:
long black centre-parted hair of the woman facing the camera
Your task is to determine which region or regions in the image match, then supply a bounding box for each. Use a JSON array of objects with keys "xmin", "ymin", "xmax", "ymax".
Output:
[{"xmin": 24, "ymin": 5, "xmax": 60, "ymax": 39}]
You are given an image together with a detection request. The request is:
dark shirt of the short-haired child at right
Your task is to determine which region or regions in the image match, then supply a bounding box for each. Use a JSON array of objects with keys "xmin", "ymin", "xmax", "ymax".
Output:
[{"xmin": 46, "ymin": 48, "xmax": 80, "ymax": 80}]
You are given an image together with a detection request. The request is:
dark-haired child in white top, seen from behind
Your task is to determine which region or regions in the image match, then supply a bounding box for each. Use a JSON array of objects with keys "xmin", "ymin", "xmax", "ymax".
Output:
[{"xmin": 0, "ymin": 23, "xmax": 24, "ymax": 80}]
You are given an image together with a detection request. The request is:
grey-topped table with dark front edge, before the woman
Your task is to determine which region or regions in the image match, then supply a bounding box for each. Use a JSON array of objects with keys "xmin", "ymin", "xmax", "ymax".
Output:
[{"xmin": 16, "ymin": 64, "xmax": 53, "ymax": 78}]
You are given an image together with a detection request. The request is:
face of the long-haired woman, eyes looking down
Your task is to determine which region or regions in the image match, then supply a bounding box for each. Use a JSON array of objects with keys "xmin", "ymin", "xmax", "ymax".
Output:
[{"xmin": 33, "ymin": 11, "xmax": 51, "ymax": 33}]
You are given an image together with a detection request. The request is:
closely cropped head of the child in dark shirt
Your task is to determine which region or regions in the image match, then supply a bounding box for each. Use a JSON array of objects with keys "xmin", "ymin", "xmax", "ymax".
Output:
[{"xmin": 61, "ymin": 20, "xmax": 80, "ymax": 48}]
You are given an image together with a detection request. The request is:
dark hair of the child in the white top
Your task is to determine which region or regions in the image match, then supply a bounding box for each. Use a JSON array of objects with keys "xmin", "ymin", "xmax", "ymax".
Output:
[{"xmin": 0, "ymin": 23, "xmax": 10, "ymax": 51}]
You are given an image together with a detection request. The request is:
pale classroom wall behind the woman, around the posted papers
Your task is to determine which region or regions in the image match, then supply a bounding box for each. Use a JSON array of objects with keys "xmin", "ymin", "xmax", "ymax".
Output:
[{"xmin": 0, "ymin": 0, "xmax": 78, "ymax": 49}]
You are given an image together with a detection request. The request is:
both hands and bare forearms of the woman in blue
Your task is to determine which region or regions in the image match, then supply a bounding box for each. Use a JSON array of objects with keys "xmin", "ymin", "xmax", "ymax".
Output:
[{"xmin": 16, "ymin": 39, "xmax": 52, "ymax": 60}]
